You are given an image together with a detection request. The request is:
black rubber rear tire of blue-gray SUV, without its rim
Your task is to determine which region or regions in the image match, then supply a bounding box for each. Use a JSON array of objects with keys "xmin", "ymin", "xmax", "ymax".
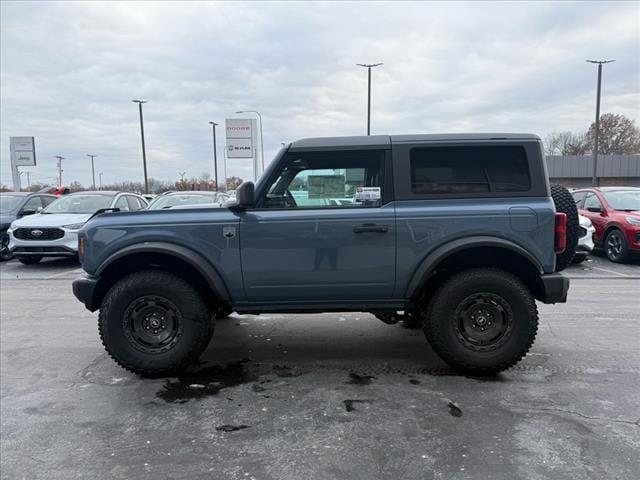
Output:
[{"xmin": 423, "ymin": 268, "xmax": 538, "ymax": 375}]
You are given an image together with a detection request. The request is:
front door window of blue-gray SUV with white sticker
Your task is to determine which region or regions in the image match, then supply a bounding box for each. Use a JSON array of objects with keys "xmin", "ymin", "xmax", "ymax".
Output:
[{"xmin": 258, "ymin": 151, "xmax": 384, "ymax": 209}]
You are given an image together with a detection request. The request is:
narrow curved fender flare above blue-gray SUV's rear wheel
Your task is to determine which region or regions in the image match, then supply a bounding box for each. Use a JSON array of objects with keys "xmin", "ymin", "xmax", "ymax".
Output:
[{"xmin": 405, "ymin": 235, "xmax": 543, "ymax": 298}]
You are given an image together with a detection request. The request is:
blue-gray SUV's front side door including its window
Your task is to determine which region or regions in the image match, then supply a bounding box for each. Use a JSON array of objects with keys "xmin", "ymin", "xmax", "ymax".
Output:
[{"xmin": 240, "ymin": 151, "xmax": 396, "ymax": 303}]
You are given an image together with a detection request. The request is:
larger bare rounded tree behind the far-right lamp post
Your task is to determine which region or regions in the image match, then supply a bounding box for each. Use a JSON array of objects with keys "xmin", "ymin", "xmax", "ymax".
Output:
[{"xmin": 586, "ymin": 113, "xmax": 640, "ymax": 155}]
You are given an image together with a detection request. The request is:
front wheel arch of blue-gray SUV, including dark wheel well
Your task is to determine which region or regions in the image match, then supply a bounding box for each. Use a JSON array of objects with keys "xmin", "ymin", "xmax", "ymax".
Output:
[{"xmin": 93, "ymin": 242, "xmax": 230, "ymax": 312}]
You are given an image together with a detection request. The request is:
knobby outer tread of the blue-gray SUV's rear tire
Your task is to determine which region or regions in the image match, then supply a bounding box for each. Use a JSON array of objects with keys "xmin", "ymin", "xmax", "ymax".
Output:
[{"xmin": 422, "ymin": 268, "xmax": 538, "ymax": 375}]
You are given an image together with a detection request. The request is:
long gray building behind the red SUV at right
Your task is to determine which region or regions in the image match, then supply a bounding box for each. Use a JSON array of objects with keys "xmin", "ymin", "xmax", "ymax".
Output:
[{"xmin": 547, "ymin": 155, "xmax": 640, "ymax": 188}]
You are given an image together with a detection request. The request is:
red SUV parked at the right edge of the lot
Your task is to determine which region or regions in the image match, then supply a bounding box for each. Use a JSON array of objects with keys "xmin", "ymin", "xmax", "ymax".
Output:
[{"xmin": 572, "ymin": 187, "xmax": 640, "ymax": 262}]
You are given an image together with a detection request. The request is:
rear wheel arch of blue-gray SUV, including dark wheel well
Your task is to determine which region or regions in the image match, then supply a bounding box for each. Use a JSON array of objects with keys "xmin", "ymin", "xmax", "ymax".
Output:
[{"xmin": 405, "ymin": 236, "xmax": 544, "ymax": 301}]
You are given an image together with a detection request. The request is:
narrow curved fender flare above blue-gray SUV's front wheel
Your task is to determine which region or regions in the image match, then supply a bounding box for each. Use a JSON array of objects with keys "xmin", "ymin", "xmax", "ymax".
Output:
[{"xmin": 94, "ymin": 242, "xmax": 231, "ymax": 302}]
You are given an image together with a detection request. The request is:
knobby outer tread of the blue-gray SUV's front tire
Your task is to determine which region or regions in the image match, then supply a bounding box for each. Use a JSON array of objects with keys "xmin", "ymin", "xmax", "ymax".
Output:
[{"xmin": 98, "ymin": 270, "xmax": 214, "ymax": 376}]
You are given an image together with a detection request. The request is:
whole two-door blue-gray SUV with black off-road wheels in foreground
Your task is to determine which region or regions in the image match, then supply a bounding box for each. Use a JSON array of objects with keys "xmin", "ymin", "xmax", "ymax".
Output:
[{"xmin": 73, "ymin": 134, "xmax": 577, "ymax": 375}]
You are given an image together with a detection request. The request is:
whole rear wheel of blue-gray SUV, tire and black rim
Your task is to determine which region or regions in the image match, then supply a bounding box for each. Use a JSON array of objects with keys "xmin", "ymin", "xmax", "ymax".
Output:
[{"xmin": 423, "ymin": 268, "xmax": 538, "ymax": 375}]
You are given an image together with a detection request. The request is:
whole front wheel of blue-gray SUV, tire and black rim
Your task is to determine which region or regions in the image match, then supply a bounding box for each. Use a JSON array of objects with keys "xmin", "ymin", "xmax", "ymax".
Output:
[{"xmin": 98, "ymin": 270, "xmax": 213, "ymax": 376}]
